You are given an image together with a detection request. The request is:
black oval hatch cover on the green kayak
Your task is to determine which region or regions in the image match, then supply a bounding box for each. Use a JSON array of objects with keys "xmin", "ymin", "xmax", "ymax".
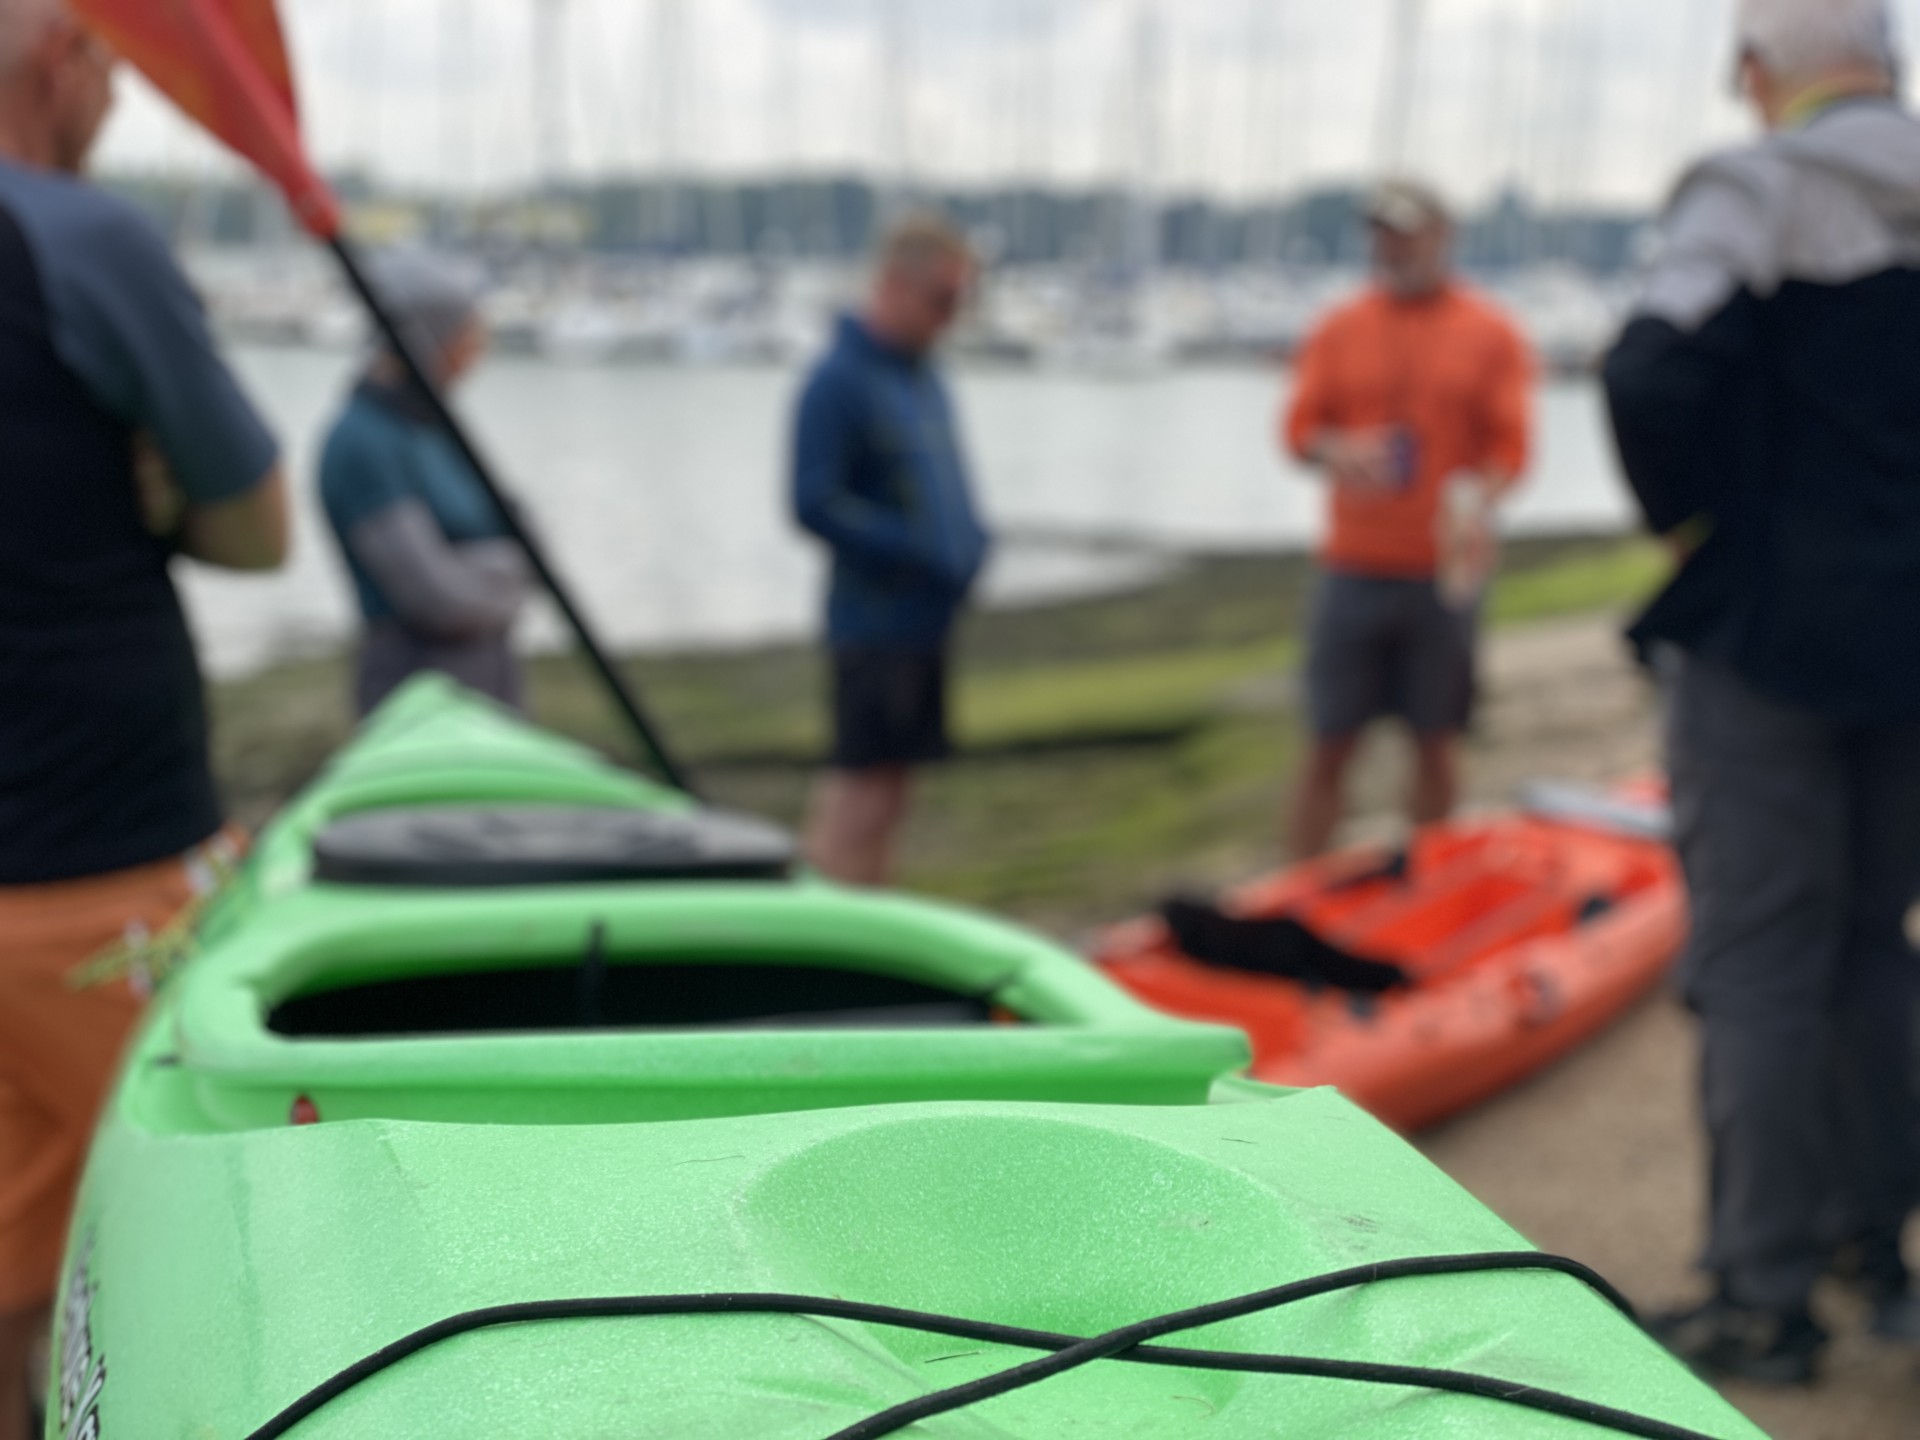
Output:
[{"xmin": 313, "ymin": 804, "xmax": 793, "ymax": 889}]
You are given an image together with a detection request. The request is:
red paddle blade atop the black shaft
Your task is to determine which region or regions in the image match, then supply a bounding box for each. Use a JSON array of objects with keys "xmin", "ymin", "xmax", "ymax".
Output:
[{"xmin": 71, "ymin": 0, "xmax": 340, "ymax": 240}]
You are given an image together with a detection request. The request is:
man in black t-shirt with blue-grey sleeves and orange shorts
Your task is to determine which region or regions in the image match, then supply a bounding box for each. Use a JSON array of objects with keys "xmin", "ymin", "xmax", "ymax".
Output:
[{"xmin": 0, "ymin": 0, "xmax": 288, "ymax": 1440}]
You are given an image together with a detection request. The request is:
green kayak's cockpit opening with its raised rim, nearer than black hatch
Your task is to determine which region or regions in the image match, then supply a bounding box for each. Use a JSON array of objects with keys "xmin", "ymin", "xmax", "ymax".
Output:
[{"xmin": 136, "ymin": 879, "xmax": 1246, "ymax": 1131}]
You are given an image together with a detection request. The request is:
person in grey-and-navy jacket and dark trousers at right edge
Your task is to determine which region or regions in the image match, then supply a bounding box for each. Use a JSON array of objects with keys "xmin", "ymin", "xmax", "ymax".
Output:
[{"xmin": 1605, "ymin": 0, "xmax": 1920, "ymax": 1382}]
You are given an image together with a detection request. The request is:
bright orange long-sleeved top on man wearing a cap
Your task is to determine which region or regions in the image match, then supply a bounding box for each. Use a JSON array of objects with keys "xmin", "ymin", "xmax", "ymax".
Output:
[{"xmin": 1286, "ymin": 284, "xmax": 1534, "ymax": 580}]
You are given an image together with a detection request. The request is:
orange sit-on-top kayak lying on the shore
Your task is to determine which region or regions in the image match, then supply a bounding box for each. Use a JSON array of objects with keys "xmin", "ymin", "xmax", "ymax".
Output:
[{"xmin": 1096, "ymin": 787, "xmax": 1686, "ymax": 1131}]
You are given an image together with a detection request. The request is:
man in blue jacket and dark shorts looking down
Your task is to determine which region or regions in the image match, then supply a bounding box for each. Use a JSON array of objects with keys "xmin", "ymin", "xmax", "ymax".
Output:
[{"xmin": 791, "ymin": 213, "xmax": 991, "ymax": 885}]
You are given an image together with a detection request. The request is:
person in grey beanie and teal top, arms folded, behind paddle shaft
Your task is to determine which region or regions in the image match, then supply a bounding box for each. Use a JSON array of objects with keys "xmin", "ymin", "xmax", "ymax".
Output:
[{"xmin": 321, "ymin": 253, "xmax": 528, "ymax": 714}]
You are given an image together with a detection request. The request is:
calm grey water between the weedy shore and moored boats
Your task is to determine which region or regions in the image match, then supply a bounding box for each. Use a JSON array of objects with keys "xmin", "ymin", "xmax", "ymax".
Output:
[{"xmin": 186, "ymin": 349, "xmax": 1628, "ymax": 674}]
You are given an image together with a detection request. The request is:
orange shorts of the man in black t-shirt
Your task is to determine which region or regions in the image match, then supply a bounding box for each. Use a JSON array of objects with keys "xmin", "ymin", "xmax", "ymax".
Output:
[{"xmin": 0, "ymin": 837, "xmax": 232, "ymax": 1313}]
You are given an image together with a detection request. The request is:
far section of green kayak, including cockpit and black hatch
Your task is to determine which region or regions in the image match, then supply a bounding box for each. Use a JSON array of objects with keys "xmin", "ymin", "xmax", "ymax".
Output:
[{"xmin": 123, "ymin": 680, "xmax": 1248, "ymax": 1133}]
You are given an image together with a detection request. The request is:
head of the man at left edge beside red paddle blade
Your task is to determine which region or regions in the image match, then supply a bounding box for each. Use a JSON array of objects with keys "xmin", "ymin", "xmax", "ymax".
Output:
[{"xmin": 0, "ymin": 0, "xmax": 113, "ymax": 173}]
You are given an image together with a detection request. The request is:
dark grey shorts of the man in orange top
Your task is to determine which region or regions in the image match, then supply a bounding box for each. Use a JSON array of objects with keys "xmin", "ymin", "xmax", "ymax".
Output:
[{"xmin": 1308, "ymin": 572, "xmax": 1480, "ymax": 739}]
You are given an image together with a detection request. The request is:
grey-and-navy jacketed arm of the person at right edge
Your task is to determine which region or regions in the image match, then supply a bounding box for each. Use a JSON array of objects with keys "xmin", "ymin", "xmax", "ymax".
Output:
[{"xmin": 1605, "ymin": 161, "xmax": 1774, "ymax": 545}]
